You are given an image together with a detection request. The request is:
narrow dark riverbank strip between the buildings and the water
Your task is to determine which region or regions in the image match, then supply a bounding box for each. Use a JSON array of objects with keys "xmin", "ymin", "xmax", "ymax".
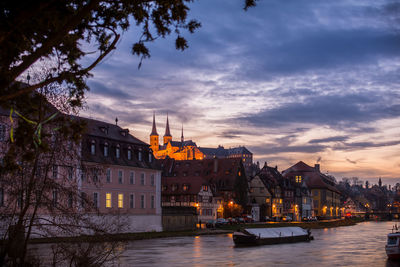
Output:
[{"xmin": 30, "ymin": 218, "xmax": 363, "ymax": 244}]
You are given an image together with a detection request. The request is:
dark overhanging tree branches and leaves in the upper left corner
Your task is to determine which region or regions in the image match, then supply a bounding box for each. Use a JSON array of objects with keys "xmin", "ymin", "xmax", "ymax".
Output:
[{"xmin": 0, "ymin": 0, "xmax": 255, "ymax": 106}]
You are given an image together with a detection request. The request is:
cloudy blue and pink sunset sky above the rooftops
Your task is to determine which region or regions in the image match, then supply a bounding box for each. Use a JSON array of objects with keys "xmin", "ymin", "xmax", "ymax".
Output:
[{"xmin": 81, "ymin": 0, "xmax": 400, "ymax": 186}]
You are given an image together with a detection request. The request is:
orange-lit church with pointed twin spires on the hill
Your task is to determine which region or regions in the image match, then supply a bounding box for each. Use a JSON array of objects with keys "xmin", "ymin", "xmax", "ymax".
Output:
[{"xmin": 150, "ymin": 114, "xmax": 204, "ymax": 160}]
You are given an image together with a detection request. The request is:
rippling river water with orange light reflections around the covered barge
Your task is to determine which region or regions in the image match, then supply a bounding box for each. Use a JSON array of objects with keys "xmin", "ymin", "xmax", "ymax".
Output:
[{"xmin": 29, "ymin": 222, "xmax": 400, "ymax": 267}]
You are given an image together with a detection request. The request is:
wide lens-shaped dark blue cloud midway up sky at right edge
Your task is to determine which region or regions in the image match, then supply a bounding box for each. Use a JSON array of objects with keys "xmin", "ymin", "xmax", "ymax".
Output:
[{"xmin": 239, "ymin": 93, "xmax": 400, "ymax": 128}]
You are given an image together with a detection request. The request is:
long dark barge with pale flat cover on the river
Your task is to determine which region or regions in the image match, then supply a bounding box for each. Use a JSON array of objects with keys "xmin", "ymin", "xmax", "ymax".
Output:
[{"xmin": 233, "ymin": 227, "xmax": 314, "ymax": 246}]
